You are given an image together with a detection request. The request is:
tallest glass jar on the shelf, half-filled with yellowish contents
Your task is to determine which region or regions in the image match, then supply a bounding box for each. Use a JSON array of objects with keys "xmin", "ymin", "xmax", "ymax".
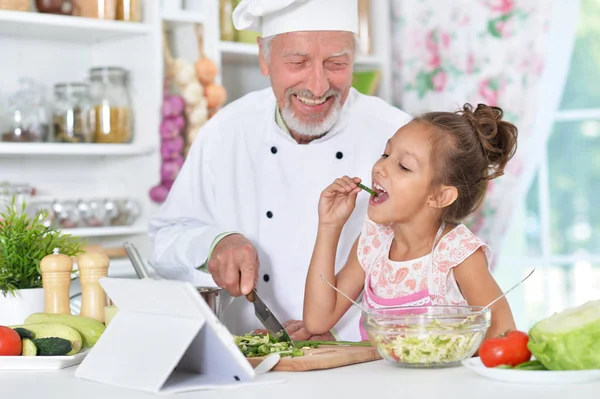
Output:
[{"xmin": 90, "ymin": 67, "xmax": 133, "ymax": 143}]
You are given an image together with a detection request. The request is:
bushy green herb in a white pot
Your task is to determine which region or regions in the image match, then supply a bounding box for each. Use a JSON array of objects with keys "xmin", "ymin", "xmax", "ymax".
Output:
[{"xmin": 0, "ymin": 198, "xmax": 84, "ymax": 325}]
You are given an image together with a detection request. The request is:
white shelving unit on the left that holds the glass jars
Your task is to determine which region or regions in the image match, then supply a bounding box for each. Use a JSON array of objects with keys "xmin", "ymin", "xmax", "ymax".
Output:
[{"xmin": 0, "ymin": 0, "xmax": 162, "ymax": 282}]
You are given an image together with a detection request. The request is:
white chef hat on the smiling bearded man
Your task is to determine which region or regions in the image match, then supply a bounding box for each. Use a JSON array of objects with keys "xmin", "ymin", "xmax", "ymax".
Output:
[{"xmin": 233, "ymin": 0, "xmax": 358, "ymax": 37}]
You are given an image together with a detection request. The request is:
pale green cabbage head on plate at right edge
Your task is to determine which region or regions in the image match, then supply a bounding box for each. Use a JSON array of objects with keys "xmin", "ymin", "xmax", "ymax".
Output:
[{"xmin": 527, "ymin": 300, "xmax": 600, "ymax": 370}]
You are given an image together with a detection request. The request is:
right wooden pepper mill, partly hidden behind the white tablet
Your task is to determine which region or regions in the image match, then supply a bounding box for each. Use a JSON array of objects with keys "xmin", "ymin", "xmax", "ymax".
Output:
[{"xmin": 77, "ymin": 252, "xmax": 110, "ymax": 323}]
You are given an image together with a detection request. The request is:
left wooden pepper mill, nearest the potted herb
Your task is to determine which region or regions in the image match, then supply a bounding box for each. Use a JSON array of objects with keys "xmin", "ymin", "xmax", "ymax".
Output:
[{"xmin": 40, "ymin": 248, "xmax": 73, "ymax": 314}]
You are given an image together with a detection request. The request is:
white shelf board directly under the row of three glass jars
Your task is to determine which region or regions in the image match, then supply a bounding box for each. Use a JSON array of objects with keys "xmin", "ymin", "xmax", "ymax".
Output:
[{"xmin": 0, "ymin": 143, "xmax": 154, "ymax": 156}]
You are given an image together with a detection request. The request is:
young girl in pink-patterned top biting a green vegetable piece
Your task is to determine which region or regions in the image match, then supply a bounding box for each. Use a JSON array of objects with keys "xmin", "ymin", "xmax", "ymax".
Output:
[{"xmin": 303, "ymin": 104, "xmax": 517, "ymax": 340}]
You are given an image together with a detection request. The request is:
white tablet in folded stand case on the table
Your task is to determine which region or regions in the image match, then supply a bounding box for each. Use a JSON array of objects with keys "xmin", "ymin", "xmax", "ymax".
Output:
[{"xmin": 75, "ymin": 278, "xmax": 256, "ymax": 393}]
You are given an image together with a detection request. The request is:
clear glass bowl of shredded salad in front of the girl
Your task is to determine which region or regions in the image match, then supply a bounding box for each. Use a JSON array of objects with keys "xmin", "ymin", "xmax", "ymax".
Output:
[{"xmin": 362, "ymin": 305, "xmax": 491, "ymax": 368}]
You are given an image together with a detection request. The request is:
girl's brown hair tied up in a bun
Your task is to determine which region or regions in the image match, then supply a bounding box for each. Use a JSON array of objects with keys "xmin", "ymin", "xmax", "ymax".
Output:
[{"xmin": 413, "ymin": 103, "xmax": 518, "ymax": 223}]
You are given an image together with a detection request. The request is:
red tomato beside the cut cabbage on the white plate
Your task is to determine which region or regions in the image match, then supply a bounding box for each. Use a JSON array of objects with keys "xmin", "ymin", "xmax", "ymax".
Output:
[{"xmin": 479, "ymin": 331, "xmax": 531, "ymax": 367}]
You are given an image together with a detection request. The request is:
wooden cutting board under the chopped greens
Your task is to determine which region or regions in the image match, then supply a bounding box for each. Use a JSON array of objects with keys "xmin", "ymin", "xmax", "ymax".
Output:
[{"xmin": 248, "ymin": 345, "xmax": 381, "ymax": 371}]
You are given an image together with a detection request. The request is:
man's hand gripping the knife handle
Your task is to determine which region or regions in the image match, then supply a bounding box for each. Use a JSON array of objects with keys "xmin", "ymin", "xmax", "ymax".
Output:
[{"xmin": 208, "ymin": 234, "xmax": 259, "ymax": 297}]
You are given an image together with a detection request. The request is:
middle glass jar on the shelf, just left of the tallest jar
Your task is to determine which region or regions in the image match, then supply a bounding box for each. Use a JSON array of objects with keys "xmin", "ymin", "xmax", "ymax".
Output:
[{"xmin": 52, "ymin": 83, "xmax": 92, "ymax": 143}]
